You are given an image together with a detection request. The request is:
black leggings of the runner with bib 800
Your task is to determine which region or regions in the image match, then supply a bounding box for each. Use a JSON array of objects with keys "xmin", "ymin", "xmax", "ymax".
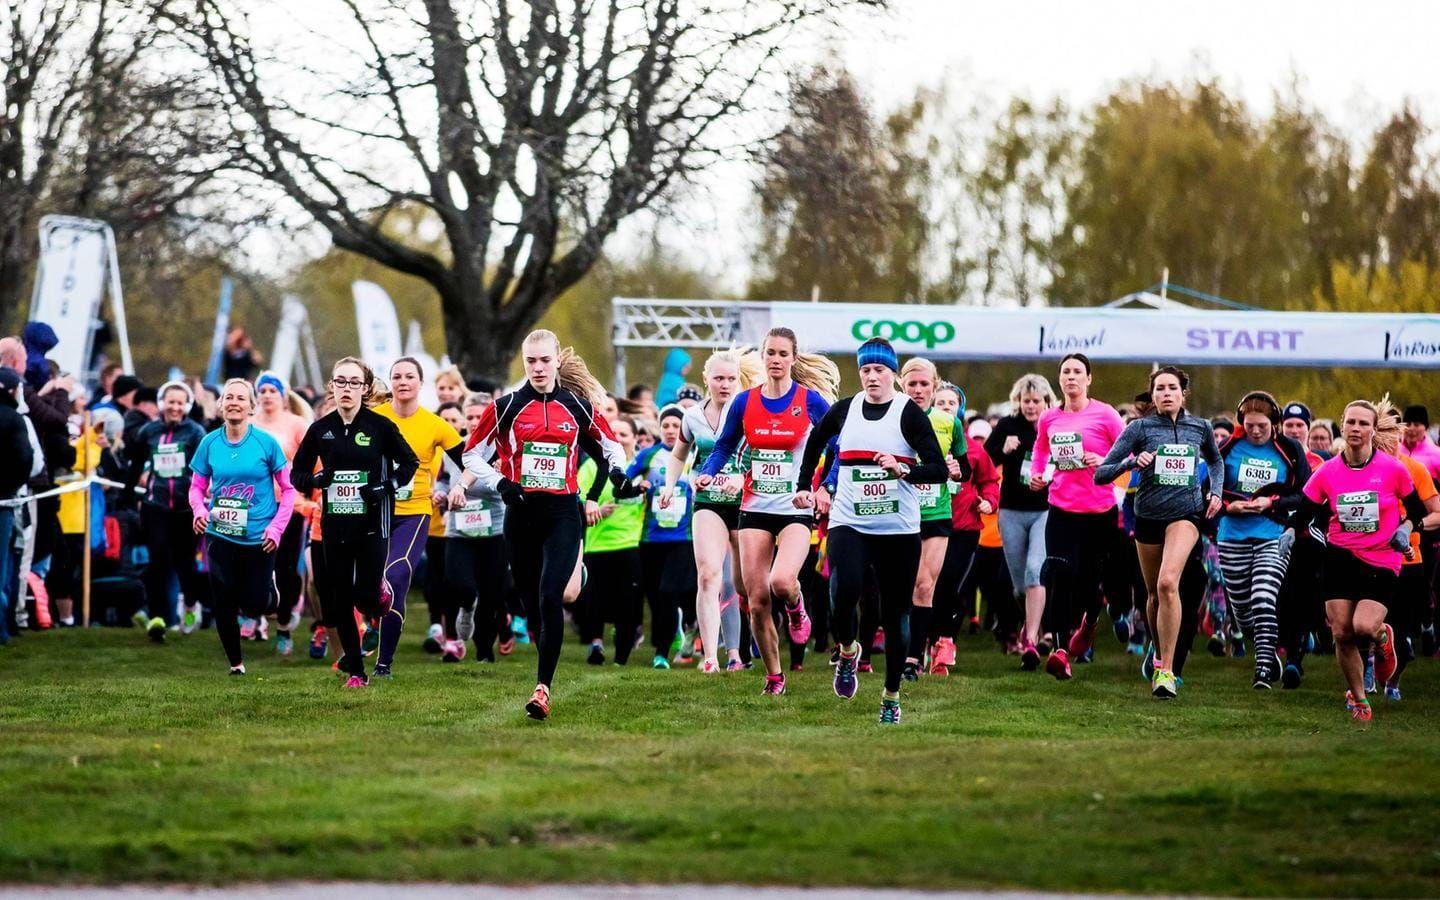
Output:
[{"xmin": 827, "ymin": 526, "xmax": 920, "ymax": 691}]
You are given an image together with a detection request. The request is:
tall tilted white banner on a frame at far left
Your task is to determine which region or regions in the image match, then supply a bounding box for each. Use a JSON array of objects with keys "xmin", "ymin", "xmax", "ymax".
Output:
[{"xmin": 30, "ymin": 216, "xmax": 109, "ymax": 377}]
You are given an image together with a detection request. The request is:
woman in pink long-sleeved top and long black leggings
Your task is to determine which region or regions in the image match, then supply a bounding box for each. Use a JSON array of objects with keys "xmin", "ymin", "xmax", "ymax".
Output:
[{"xmin": 1021, "ymin": 353, "xmax": 1125, "ymax": 681}]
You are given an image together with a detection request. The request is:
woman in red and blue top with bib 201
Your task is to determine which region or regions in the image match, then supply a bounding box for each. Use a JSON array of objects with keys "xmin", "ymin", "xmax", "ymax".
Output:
[{"xmin": 694, "ymin": 328, "xmax": 840, "ymax": 694}]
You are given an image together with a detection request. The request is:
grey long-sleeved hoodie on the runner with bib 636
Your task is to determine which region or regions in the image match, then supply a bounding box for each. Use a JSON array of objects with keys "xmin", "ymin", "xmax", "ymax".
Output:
[{"xmin": 1094, "ymin": 409, "xmax": 1225, "ymax": 521}]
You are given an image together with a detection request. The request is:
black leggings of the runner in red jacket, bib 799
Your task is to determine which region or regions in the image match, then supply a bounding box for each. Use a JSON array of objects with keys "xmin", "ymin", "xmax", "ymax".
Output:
[{"xmin": 505, "ymin": 491, "xmax": 585, "ymax": 687}]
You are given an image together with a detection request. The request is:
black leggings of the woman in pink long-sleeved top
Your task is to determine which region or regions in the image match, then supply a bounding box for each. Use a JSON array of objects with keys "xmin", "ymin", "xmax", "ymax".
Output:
[{"xmin": 1041, "ymin": 507, "xmax": 1119, "ymax": 648}]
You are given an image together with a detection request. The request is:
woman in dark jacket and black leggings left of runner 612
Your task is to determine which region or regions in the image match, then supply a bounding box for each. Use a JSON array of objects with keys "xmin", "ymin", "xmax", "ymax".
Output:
[{"xmin": 125, "ymin": 382, "xmax": 206, "ymax": 641}]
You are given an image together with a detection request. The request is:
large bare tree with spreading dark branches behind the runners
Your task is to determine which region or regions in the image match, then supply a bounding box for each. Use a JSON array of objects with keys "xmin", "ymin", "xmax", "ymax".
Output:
[{"xmin": 176, "ymin": 0, "xmax": 886, "ymax": 377}]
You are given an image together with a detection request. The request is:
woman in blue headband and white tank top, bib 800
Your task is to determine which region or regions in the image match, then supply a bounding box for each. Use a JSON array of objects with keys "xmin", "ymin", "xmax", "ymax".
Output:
[{"xmin": 794, "ymin": 337, "xmax": 950, "ymax": 724}]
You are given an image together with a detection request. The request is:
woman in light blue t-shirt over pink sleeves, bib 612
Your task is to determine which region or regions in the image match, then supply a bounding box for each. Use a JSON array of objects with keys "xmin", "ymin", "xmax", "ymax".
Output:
[{"xmin": 190, "ymin": 379, "xmax": 295, "ymax": 675}]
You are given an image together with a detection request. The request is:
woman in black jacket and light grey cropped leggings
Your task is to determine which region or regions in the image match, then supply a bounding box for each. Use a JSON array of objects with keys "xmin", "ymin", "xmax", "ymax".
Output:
[{"xmin": 985, "ymin": 373, "xmax": 1056, "ymax": 670}]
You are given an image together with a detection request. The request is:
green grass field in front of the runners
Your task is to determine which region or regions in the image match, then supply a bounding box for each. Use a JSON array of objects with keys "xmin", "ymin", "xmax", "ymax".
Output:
[{"xmin": 0, "ymin": 609, "xmax": 1440, "ymax": 896}]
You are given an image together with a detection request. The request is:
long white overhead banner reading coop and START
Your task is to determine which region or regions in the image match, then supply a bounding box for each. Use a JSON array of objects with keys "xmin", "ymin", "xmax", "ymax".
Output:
[{"xmin": 743, "ymin": 302, "xmax": 1440, "ymax": 369}]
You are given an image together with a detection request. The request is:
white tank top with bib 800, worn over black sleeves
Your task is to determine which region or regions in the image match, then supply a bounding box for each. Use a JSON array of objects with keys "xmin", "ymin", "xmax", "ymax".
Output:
[{"xmin": 829, "ymin": 393, "xmax": 920, "ymax": 534}]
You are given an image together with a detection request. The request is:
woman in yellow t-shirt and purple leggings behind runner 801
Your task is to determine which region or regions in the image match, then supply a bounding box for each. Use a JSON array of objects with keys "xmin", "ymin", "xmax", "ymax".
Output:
[{"xmin": 374, "ymin": 356, "xmax": 462, "ymax": 678}]
